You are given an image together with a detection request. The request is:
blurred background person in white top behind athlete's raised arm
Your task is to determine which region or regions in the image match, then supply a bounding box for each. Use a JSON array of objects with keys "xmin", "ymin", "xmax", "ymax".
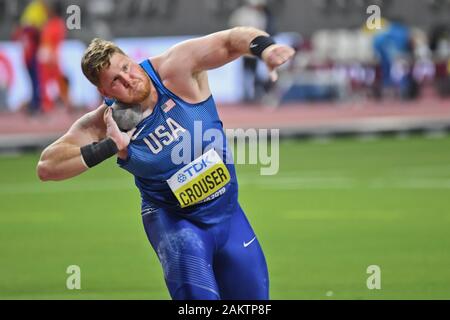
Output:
[{"xmin": 229, "ymin": 0, "xmax": 275, "ymax": 102}]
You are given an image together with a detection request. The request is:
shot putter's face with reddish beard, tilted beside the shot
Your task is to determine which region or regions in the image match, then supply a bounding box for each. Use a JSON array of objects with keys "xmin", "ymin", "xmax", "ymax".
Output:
[{"xmin": 98, "ymin": 53, "xmax": 151, "ymax": 104}]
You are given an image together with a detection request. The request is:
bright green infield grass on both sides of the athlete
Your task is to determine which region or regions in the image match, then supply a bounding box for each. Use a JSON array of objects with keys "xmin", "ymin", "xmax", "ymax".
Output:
[{"xmin": 0, "ymin": 137, "xmax": 450, "ymax": 299}]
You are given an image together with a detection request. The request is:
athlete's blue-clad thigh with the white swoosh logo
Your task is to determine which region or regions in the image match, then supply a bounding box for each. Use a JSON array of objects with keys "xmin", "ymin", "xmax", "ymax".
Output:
[{"xmin": 214, "ymin": 207, "xmax": 269, "ymax": 300}]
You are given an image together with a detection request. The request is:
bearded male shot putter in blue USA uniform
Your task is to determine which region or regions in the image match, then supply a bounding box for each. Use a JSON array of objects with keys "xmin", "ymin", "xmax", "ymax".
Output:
[{"xmin": 37, "ymin": 27, "xmax": 294, "ymax": 299}]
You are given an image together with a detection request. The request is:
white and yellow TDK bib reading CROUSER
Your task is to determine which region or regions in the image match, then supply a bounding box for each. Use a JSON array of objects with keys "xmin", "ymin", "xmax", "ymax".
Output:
[{"xmin": 167, "ymin": 149, "xmax": 230, "ymax": 208}]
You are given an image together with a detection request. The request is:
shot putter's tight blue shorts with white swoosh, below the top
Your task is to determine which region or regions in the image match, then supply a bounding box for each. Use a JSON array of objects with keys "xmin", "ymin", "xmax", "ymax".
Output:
[{"xmin": 142, "ymin": 205, "xmax": 269, "ymax": 300}]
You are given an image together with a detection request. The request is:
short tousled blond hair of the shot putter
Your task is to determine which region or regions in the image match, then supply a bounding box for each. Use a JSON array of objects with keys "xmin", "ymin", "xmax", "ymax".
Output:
[{"xmin": 81, "ymin": 38, "xmax": 125, "ymax": 86}]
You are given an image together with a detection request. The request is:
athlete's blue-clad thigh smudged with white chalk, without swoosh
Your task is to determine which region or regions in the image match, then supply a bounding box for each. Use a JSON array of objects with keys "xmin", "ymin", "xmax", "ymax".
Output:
[{"xmin": 142, "ymin": 209, "xmax": 219, "ymax": 299}]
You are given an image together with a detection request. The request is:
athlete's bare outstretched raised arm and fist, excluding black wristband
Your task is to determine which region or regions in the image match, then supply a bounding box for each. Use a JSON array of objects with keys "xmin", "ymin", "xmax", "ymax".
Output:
[{"xmin": 164, "ymin": 27, "xmax": 295, "ymax": 97}]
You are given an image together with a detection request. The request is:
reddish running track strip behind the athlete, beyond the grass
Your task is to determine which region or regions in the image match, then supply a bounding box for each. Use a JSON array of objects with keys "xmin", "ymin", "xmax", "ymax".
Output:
[{"xmin": 0, "ymin": 98, "xmax": 450, "ymax": 136}]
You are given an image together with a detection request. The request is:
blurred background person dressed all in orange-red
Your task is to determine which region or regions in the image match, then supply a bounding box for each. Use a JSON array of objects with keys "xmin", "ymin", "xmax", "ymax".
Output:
[{"xmin": 38, "ymin": 2, "xmax": 72, "ymax": 112}]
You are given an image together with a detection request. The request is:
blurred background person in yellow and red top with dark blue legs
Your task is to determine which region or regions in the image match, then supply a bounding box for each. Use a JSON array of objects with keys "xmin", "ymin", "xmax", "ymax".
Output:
[{"xmin": 13, "ymin": 0, "xmax": 48, "ymax": 114}]
